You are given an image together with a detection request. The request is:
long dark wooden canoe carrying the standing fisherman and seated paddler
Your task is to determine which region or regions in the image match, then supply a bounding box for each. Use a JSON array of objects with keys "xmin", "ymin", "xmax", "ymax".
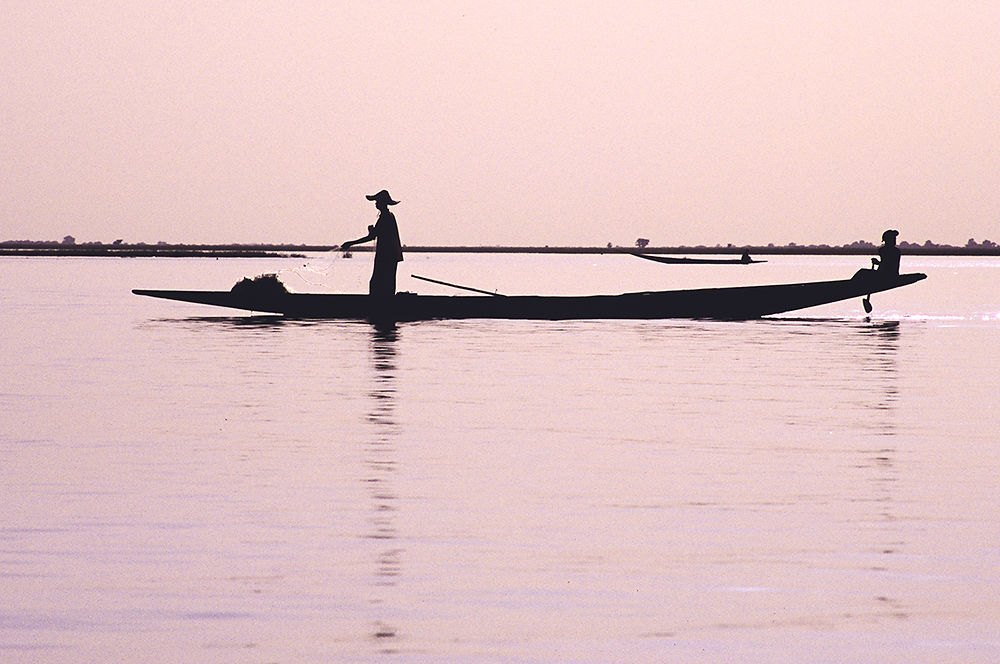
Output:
[{"xmin": 132, "ymin": 270, "xmax": 927, "ymax": 321}]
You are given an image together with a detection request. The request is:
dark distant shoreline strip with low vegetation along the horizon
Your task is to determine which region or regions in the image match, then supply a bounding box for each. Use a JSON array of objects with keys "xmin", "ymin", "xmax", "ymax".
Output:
[{"xmin": 0, "ymin": 237, "xmax": 1000, "ymax": 258}]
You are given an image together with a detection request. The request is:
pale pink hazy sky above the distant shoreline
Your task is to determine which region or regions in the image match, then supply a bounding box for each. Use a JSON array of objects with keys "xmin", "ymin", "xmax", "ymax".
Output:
[{"xmin": 0, "ymin": 0, "xmax": 1000, "ymax": 245}]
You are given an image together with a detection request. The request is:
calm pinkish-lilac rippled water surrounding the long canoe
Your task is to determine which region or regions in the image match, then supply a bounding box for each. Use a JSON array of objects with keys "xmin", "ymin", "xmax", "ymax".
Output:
[{"xmin": 0, "ymin": 254, "xmax": 1000, "ymax": 663}]
